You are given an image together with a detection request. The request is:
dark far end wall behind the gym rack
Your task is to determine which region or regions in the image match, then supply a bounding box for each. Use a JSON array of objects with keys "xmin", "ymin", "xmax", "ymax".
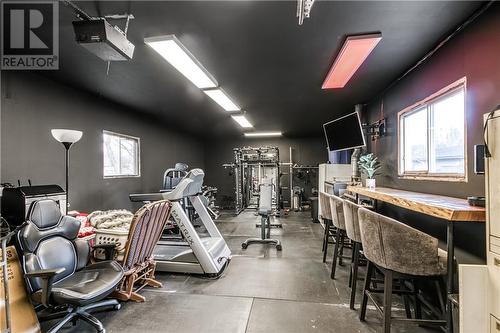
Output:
[{"xmin": 205, "ymin": 135, "xmax": 328, "ymax": 205}]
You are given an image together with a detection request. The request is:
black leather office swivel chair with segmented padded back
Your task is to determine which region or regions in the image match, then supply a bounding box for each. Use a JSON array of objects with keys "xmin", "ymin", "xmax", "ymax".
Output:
[{"xmin": 17, "ymin": 199, "xmax": 123, "ymax": 333}]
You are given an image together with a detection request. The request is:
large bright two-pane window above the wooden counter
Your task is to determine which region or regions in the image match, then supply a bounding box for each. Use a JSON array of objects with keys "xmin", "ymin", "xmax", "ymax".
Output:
[{"xmin": 399, "ymin": 79, "xmax": 467, "ymax": 181}]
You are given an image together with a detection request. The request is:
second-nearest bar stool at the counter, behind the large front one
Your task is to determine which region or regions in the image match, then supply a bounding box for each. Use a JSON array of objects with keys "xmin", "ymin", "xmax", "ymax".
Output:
[{"xmin": 343, "ymin": 200, "xmax": 361, "ymax": 310}]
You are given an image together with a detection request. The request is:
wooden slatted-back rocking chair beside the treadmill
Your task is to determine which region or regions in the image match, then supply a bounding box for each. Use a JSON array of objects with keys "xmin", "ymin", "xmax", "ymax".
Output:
[{"xmin": 114, "ymin": 200, "xmax": 172, "ymax": 302}]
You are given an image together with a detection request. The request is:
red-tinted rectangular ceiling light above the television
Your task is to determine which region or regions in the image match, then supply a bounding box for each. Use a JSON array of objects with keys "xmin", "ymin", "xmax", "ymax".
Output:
[{"xmin": 321, "ymin": 33, "xmax": 382, "ymax": 89}]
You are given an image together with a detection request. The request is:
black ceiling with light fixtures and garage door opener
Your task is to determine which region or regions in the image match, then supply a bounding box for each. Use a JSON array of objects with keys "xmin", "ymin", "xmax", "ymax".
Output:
[{"xmin": 43, "ymin": 1, "xmax": 481, "ymax": 137}]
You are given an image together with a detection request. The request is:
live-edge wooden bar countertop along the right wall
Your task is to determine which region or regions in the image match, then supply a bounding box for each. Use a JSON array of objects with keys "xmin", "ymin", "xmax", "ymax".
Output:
[{"xmin": 347, "ymin": 186, "xmax": 486, "ymax": 222}]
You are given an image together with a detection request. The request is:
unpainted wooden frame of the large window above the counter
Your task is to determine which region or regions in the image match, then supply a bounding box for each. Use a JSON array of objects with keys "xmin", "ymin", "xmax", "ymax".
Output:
[{"xmin": 397, "ymin": 77, "xmax": 468, "ymax": 182}]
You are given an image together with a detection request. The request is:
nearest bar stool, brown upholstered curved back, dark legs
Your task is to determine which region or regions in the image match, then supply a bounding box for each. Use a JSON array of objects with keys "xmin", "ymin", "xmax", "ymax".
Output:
[{"xmin": 358, "ymin": 208, "xmax": 447, "ymax": 333}]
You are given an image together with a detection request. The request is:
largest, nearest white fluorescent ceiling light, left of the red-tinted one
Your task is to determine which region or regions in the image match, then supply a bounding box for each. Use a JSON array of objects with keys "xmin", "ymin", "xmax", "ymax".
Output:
[{"xmin": 144, "ymin": 35, "xmax": 217, "ymax": 89}]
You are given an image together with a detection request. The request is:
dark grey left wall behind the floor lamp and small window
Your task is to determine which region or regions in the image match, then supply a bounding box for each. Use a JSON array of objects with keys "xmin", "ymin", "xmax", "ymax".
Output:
[{"xmin": 1, "ymin": 72, "xmax": 204, "ymax": 212}]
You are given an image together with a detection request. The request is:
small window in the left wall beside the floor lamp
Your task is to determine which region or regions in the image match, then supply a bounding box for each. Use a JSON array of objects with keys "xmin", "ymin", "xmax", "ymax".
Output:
[{"xmin": 102, "ymin": 131, "xmax": 141, "ymax": 178}]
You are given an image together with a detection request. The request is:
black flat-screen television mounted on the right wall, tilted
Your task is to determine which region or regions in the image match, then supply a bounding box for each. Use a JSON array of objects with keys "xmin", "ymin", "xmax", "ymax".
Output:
[{"xmin": 323, "ymin": 112, "xmax": 366, "ymax": 151}]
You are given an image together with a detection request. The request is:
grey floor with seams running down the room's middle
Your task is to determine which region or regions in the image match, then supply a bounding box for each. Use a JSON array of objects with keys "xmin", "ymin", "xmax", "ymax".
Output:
[{"xmin": 44, "ymin": 212, "xmax": 436, "ymax": 333}]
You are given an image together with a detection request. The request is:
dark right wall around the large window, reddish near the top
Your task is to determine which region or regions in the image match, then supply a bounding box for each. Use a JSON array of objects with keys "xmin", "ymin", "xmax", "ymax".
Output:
[{"xmin": 367, "ymin": 4, "xmax": 500, "ymax": 258}]
